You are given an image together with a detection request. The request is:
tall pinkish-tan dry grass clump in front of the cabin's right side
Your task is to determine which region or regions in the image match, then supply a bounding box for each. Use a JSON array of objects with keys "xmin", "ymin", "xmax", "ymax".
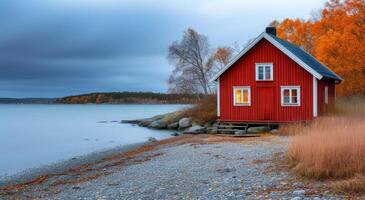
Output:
[{"xmin": 284, "ymin": 97, "xmax": 365, "ymax": 192}]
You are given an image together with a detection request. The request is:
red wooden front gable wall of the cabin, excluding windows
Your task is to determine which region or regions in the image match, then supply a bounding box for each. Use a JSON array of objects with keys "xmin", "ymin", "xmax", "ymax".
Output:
[{"xmin": 219, "ymin": 39, "xmax": 313, "ymax": 122}]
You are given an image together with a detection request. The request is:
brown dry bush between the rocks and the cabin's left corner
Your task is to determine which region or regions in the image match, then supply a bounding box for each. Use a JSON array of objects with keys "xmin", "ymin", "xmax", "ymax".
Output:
[{"xmin": 181, "ymin": 95, "xmax": 217, "ymax": 125}]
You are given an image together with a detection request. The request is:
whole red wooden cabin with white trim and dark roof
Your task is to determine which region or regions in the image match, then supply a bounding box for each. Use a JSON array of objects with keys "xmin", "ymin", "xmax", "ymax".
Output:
[{"xmin": 213, "ymin": 27, "xmax": 342, "ymax": 123}]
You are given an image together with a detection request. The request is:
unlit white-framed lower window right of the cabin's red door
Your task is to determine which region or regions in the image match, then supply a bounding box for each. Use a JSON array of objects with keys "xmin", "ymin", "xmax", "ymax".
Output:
[{"xmin": 281, "ymin": 86, "xmax": 300, "ymax": 106}]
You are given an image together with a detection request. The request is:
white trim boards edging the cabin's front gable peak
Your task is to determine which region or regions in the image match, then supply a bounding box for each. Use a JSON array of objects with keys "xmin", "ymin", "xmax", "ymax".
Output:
[{"xmin": 210, "ymin": 32, "xmax": 323, "ymax": 81}]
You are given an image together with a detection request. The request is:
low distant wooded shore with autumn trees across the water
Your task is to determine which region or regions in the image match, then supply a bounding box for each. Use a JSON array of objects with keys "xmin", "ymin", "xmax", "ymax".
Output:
[{"xmin": 55, "ymin": 92, "xmax": 203, "ymax": 104}]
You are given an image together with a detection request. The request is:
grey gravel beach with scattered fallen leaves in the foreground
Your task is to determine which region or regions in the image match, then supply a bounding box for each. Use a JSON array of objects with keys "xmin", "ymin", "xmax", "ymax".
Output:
[{"xmin": 0, "ymin": 136, "xmax": 354, "ymax": 200}]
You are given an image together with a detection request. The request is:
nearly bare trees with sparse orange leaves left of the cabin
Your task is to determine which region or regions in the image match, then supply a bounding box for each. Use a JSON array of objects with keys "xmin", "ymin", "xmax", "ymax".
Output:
[{"xmin": 168, "ymin": 28, "xmax": 233, "ymax": 94}]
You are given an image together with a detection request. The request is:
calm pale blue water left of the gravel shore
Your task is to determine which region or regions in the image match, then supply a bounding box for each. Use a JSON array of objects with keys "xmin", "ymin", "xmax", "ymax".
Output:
[{"xmin": 0, "ymin": 104, "xmax": 184, "ymax": 177}]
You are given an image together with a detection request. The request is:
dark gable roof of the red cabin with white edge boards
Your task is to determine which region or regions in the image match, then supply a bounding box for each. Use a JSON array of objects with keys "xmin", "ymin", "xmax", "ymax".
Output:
[{"xmin": 211, "ymin": 32, "xmax": 342, "ymax": 82}]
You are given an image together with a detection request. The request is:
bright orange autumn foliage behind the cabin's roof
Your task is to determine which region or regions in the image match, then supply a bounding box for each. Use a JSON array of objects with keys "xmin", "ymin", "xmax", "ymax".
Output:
[{"xmin": 277, "ymin": 0, "xmax": 365, "ymax": 95}]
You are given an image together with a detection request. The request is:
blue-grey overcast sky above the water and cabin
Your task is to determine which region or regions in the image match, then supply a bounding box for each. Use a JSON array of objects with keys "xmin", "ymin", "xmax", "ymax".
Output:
[{"xmin": 0, "ymin": 0, "xmax": 324, "ymax": 97}]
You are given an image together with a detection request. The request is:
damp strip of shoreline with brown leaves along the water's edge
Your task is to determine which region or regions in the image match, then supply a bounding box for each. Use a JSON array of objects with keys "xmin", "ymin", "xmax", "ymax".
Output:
[{"xmin": 0, "ymin": 135, "xmax": 191, "ymax": 191}]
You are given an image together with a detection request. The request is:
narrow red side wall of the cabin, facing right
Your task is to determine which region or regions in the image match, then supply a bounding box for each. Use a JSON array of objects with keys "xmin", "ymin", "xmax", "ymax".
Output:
[{"xmin": 317, "ymin": 80, "xmax": 336, "ymax": 114}]
